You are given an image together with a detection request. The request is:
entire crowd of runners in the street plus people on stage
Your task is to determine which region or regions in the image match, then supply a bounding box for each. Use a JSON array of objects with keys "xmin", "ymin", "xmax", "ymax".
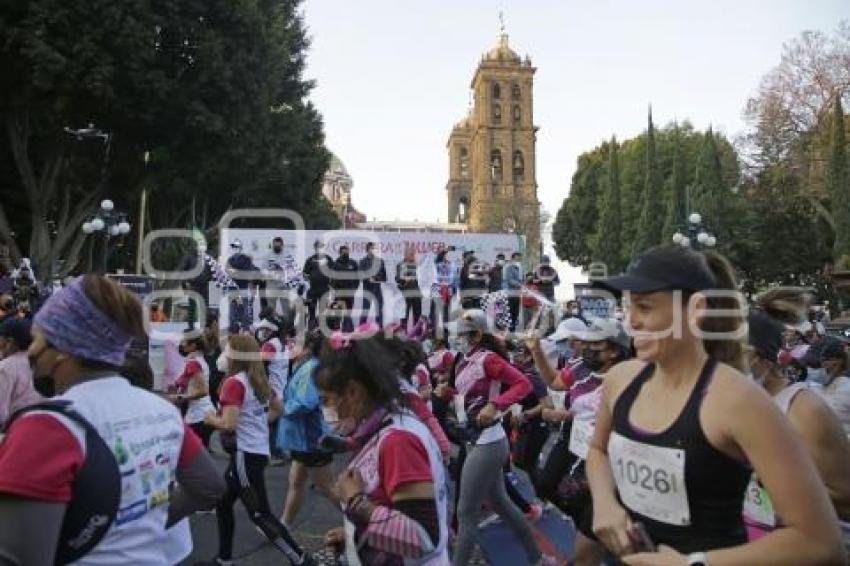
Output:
[{"xmin": 0, "ymin": 246, "xmax": 850, "ymax": 566}]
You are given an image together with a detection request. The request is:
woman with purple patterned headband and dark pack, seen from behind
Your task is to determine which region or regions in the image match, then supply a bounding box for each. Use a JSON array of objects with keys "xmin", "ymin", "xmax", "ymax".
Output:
[{"xmin": 0, "ymin": 275, "xmax": 224, "ymax": 566}]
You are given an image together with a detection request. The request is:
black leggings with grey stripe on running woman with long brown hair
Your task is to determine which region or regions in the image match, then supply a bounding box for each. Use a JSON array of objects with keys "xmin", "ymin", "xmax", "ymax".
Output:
[{"xmin": 216, "ymin": 450, "xmax": 306, "ymax": 564}]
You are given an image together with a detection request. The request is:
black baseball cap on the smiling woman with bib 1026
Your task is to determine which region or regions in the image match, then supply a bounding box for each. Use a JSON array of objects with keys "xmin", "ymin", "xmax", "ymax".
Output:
[{"xmin": 593, "ymin": 246, "xmax": 717, "ymax": 293}]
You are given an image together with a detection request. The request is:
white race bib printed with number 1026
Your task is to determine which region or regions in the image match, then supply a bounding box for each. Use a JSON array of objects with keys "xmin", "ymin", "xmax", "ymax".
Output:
[{"xmin": 608, "ymin": 433, "xmax": 691, "ymax": 526}]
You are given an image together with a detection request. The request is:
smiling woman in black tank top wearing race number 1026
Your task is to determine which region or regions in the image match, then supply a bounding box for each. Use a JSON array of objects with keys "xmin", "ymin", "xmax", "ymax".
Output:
[{"xmin": 587, "ymin": 246, "xmax": 846, "ymax": 566}]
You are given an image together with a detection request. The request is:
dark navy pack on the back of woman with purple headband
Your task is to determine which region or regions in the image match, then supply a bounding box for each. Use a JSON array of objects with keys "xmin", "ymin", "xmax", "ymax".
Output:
[{"xmin": 9, "ymin": 401, "xmax": 121, "ymax": 564}]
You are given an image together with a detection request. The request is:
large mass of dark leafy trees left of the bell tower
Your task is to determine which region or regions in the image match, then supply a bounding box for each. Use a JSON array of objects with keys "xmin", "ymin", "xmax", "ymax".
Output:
[{"xmin": 0, "ymin": 0, "xmax": 335, "ymax": 279}]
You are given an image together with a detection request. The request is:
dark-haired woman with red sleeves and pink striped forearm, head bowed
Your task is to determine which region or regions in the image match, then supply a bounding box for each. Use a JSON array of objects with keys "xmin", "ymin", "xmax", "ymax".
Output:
[{"xmin": 316, "ymin": 335, "xmax": 449, "ymax": 566}]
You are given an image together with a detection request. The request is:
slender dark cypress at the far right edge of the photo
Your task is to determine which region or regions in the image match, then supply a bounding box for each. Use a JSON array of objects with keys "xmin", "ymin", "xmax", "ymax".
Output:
[{"xmin": 828, "ymin": 92, "xmax": 850, "ymax": 270}]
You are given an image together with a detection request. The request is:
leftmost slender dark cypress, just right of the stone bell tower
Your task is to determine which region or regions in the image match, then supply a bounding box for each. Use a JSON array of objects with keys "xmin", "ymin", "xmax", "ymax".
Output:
[{"xmin": 594, "ymin": 136, "xmax": 624, "ymax": 273}]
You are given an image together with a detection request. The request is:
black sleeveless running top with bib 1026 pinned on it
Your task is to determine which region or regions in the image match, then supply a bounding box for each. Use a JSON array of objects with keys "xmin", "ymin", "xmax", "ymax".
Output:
[{"xmin": 608, "ymin": 359, "xmax": 751, "ymax": 554}]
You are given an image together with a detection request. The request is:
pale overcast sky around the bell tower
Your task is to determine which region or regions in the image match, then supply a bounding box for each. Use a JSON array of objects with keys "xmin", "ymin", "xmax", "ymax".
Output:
[{"xmin": 304, "ymin": 0, "xmax": 850, "ymax": 300}]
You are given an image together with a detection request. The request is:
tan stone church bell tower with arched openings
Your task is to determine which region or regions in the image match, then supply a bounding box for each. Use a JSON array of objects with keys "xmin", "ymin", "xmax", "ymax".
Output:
[{"xmin": 446, "ymin": 29, "xmax": 541, "ymax": 263}]
